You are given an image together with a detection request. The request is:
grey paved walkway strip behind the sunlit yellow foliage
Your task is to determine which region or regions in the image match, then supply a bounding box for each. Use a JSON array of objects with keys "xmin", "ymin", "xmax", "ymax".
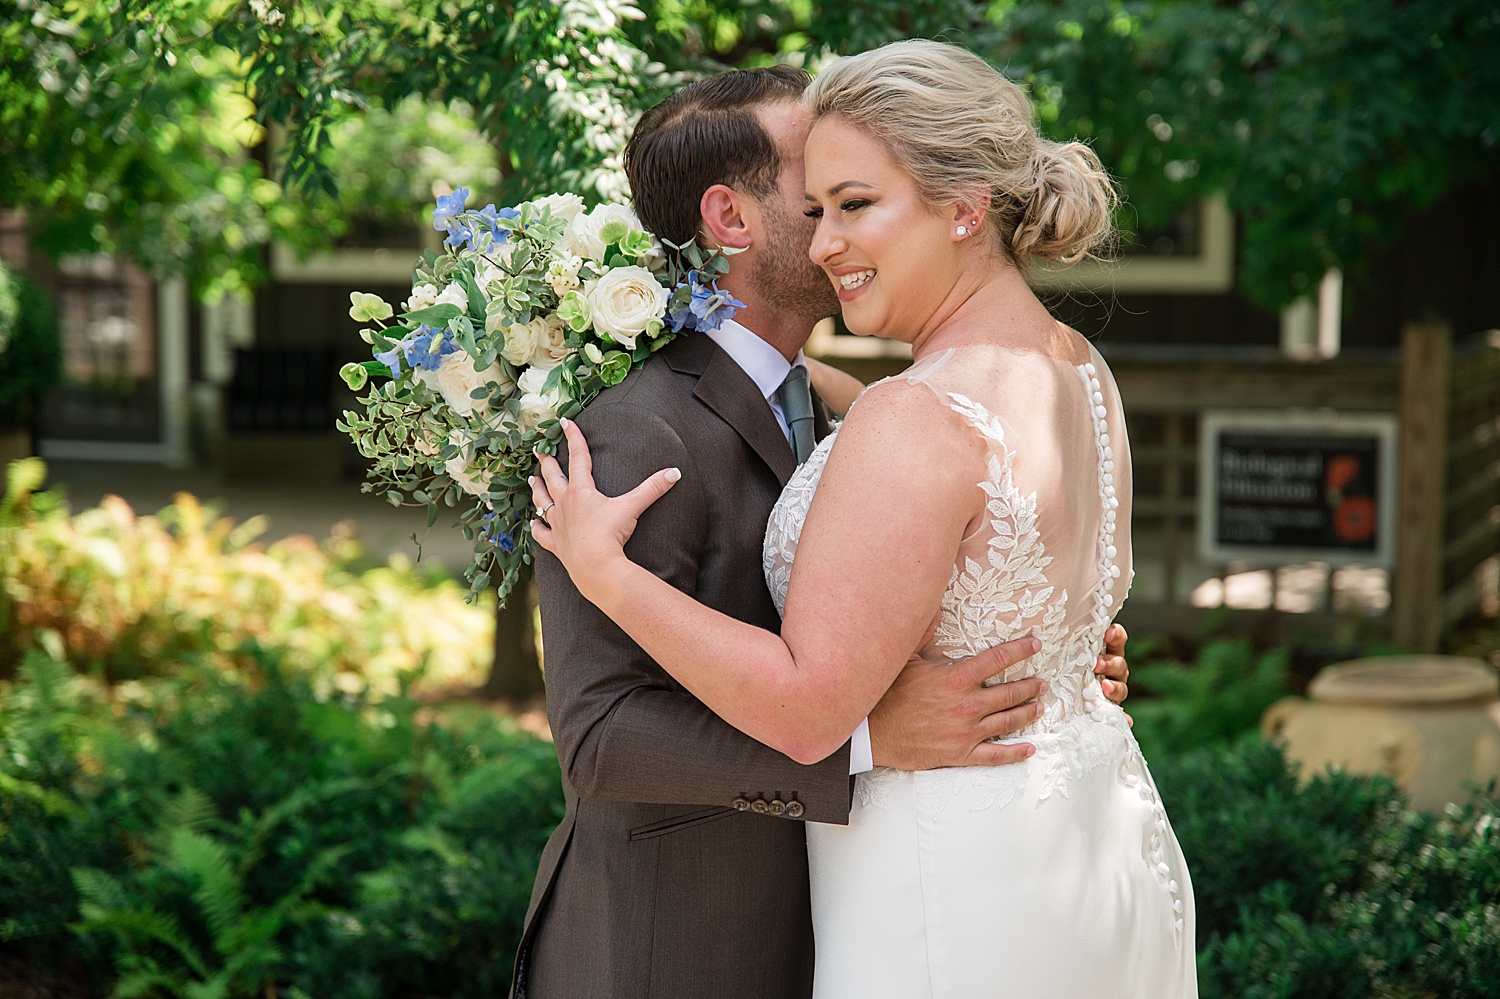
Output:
[{"xmin": 47, "ymin": 461, "xmax": 473, "ymax": 576}]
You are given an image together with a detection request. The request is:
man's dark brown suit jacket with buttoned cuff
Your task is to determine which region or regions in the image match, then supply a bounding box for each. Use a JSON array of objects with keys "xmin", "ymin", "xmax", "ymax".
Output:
[{"xmin": 515, "ymin": 335, "xmax": 852, "ymax": 999}]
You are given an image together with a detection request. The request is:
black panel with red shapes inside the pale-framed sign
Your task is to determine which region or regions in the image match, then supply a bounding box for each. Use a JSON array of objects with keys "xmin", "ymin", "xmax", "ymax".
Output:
[{"xmin": 1212, "ymin": 428, "xmax": 1383, "ymax": 555}]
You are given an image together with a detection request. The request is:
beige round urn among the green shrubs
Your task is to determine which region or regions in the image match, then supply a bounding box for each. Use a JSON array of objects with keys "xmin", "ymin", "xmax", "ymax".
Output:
[{"xmin": 1260, "ymin": 656, "xmax": 1500, "ymax": 810}]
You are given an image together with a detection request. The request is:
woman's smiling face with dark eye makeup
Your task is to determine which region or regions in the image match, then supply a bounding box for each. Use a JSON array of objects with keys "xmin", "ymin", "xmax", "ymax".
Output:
[{"xmin": 807, "ymin": 117, "xmax": 963, "ymax": 342}]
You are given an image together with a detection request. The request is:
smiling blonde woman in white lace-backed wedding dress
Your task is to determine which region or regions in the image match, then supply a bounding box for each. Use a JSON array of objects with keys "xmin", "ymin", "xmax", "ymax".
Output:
[{"xmin": 533, "ymin": 41, "xmax": 1197, "ymax": 999}]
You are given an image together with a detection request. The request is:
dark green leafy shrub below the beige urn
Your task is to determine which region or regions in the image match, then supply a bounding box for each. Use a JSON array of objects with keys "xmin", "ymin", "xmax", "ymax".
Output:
[{"xmin": 1154, "ymin": 738, "xmax": 1500, "ymax": 999}]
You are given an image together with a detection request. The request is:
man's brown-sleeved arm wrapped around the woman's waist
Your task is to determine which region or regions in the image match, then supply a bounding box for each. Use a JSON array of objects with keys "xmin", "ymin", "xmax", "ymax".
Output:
[{"xmin": 537, "ymin": 404, "xmax": 851, "ymax": 822}]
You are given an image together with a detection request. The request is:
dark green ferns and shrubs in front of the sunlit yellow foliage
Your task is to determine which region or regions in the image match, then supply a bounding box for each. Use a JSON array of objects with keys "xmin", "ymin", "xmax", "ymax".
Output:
[{"xmin": 0, "ymin": 642, "xmax": 563, "ymax": 999}]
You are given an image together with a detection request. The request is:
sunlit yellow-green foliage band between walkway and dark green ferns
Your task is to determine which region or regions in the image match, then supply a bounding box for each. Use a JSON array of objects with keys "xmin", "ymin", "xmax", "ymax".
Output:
[{"xmin": 0, "ymin": 459, "xmax": 494, "ymax": 695}]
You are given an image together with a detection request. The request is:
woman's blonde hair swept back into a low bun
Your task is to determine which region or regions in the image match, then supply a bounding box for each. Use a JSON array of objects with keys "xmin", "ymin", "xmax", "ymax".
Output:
[{"xmin": 804, "ymin": 39, "xmax": 1119, "ymax": 264}]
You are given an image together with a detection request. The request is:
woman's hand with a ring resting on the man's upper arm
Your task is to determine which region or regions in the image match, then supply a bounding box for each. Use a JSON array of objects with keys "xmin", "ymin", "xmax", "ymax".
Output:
[{"xmin": 530, "ymin": 420, "xmax": 683, "ymax": 597}]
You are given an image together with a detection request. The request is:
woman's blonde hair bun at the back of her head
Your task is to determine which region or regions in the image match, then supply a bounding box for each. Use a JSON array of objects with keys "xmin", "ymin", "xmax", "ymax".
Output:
[{"xmin": 1011, "ymin": 140, "xmax": 1119, "ymax": 264}]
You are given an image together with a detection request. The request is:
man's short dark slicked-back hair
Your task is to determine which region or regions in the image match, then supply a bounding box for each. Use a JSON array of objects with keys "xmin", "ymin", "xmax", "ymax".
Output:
[{"xmin": 626, "ymin": 66, "xmax": 812, "ymax": 245}]
